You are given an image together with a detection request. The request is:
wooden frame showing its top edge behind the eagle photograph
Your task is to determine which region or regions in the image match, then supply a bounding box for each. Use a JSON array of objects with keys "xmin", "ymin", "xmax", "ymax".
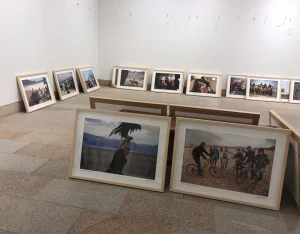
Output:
[{"xmin": 90, "ymin": 97, "xmax": 168, "ymax": 116}]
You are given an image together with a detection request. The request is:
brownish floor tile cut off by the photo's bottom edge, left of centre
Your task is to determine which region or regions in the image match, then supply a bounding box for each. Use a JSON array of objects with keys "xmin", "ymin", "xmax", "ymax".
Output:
[{"xmin": 68, "ymin": 211, "xmax": 178, "ymax": 234}]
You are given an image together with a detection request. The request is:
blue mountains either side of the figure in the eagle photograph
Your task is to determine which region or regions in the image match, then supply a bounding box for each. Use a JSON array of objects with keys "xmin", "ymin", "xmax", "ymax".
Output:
[{"xmin": 83, "ymin": 133, "xmax": 158, "ymax": 156}]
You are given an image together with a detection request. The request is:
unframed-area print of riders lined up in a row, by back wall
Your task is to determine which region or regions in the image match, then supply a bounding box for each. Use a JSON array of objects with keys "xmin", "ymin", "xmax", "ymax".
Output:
[{"xmin": 249, "ymin": 79, "xmax": 279, "ymax": 99}]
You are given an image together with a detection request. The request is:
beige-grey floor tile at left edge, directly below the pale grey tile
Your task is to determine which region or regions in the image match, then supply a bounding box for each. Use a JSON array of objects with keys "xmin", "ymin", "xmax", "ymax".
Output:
[{"xmin": 0, "ymin": 170, "xmax": 51, "ymax": 198}]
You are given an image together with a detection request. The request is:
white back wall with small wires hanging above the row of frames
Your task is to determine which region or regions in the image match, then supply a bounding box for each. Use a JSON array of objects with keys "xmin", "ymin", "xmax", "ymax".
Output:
[{"xmin": 98, "ymin": 0, "xmax": 300, "ymax": 88}]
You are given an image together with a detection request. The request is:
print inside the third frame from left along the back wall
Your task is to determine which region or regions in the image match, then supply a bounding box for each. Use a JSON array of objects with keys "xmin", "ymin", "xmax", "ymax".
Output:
[{"xmin": 190, "ymin": 75, "xmax": 218, "ymax": 94}]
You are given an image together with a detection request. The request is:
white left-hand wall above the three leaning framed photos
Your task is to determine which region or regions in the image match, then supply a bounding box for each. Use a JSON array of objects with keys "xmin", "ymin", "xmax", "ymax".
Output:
[{"xmin": 0, "ymin": 0, "xmax": 98, "ymax": 106}]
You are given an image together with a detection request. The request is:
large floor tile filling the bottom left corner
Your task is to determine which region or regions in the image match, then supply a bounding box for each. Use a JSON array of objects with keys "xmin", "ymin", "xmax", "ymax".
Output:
[{"xmin": 0, "ymin": 196, "xmax": 82, "ymax": 234}]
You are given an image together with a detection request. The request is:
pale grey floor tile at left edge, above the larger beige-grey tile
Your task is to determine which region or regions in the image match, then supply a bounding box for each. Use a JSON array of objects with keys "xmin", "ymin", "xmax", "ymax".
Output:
[{"xmin": 0, "ymin": 153, "xmax": 49, "ymax": 173}]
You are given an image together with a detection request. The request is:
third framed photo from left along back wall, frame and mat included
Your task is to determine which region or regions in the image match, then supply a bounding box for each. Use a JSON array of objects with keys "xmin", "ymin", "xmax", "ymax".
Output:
[{"xmin": 186, "ymin": 73, "xmax": 222, "ymax": 97}]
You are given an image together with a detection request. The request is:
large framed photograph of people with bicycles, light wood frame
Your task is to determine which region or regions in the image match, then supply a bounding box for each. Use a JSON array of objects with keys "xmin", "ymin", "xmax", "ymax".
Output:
[{"xmin": 171, "ymin": 118, "xmax": 290, "ymax": 210}]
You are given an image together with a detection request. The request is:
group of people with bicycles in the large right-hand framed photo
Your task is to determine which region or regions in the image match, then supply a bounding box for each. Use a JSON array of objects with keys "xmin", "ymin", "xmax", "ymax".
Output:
[{"xmin": 192, "ymin": 142, "xmax": 270, "ymax": 181}]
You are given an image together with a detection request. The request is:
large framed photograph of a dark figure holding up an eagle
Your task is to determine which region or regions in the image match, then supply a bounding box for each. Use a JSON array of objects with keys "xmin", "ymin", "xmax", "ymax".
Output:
[{"xmin": 70, "ymin": 109, "xmax": 170, "ymax": 192}]
